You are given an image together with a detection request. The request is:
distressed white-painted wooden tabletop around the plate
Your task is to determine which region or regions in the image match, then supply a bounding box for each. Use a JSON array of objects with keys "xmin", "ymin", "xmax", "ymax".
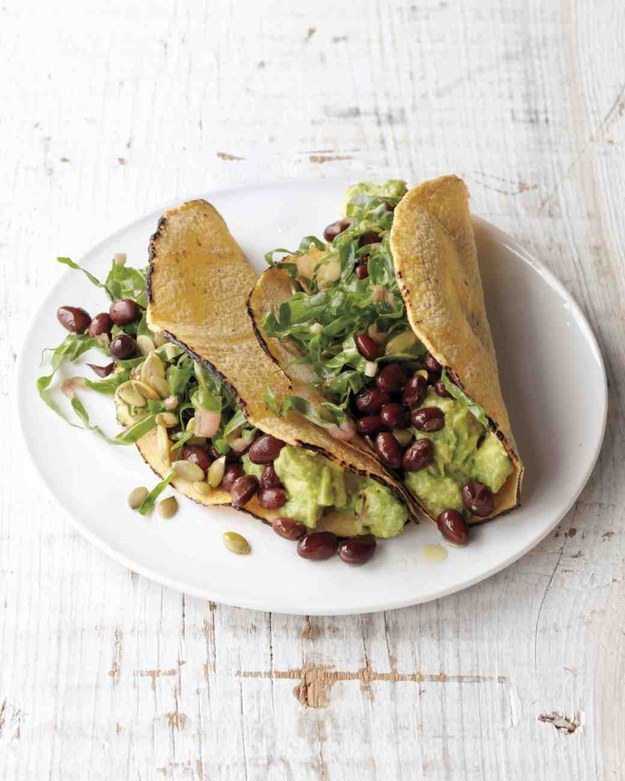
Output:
[{"xmin": 0, "ymin": 0, "xmax": 625, "ymax": 781}]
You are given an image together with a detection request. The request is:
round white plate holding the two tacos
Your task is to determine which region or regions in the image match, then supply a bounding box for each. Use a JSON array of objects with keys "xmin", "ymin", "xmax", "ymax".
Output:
[{"xmin": 18, "ymin": 181, "xmax": 607, "ymax": 615}]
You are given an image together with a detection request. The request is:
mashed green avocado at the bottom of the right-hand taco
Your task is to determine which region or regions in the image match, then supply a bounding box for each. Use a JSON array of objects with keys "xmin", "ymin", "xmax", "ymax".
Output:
[{"xmin": 405, "ymin": 388, "xmax": 512, "ymax": 515}]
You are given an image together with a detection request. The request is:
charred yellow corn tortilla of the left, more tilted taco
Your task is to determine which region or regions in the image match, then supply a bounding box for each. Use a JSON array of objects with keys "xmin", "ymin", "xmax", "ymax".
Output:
[{"xmin": 144, "ymin": 200, "xmax": 412, "ymax": 535}]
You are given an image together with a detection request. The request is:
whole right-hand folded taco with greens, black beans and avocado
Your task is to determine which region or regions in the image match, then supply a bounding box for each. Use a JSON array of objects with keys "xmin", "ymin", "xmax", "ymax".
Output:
[{"xmin": 248, "ymin": 176, "xmax": 523, "ymax": 542}]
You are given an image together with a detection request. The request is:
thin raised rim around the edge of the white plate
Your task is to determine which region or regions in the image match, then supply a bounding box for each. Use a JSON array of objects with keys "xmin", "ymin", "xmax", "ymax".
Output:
[{"xmin": 13, "ymin": 177, "xmax": 608, "ymax": 616}]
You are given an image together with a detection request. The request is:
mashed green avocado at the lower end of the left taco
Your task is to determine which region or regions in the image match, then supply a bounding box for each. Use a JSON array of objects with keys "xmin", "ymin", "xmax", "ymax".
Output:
[{"xmin": 272, "ymin": 445, "xmax": 408, "ymax": 537}]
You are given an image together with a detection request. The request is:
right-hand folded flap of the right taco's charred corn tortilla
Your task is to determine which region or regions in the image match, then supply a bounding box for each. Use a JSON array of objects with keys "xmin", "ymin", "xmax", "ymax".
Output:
[{"xmin": 390, "ymin": 176, "xmax": 523, "ymax": 520}]
